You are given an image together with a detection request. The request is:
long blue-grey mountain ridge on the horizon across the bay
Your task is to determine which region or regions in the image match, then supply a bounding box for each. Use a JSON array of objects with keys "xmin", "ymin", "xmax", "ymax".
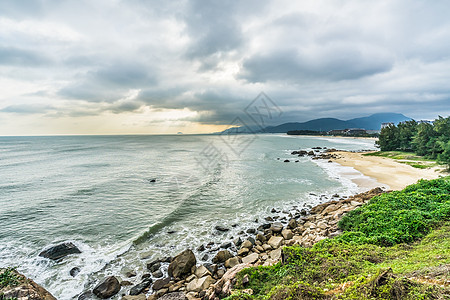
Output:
[{"xmin": 218, "ymin": 113, "xmax": 411, "ymax": 134}]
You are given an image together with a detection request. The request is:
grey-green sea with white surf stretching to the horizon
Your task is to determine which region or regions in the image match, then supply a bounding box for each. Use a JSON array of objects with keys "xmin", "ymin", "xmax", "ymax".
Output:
[{"xmin": 0, "ymin": 134, "xmax": 374, "ymax": 300}]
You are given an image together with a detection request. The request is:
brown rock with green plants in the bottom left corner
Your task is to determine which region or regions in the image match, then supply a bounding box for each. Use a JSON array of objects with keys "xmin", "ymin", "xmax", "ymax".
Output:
[{"xmin": 0, "ymin": 268, "xmax": 57, "ymax": 300}]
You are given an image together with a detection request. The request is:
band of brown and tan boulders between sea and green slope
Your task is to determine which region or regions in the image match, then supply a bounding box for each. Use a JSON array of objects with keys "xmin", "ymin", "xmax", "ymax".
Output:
[{"xmin": 78, "ymin": 188, "xmax": 383, "ymax": 300}]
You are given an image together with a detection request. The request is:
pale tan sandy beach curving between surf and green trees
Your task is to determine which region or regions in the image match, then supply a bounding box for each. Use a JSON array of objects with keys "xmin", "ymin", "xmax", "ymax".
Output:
[{"xmin": 332, "ymin": 151, "xmax": 445, "ymax": 190}]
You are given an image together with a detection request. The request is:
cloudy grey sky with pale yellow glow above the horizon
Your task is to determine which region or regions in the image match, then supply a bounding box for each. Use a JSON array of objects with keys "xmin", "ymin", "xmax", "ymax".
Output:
[{"xmin": 0, "ymin": 0, "xmax": 450, "ymax": 135}]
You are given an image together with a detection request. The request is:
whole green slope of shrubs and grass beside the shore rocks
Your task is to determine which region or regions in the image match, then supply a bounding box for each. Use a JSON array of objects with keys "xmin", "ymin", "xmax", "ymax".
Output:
[{"xmin": 227, "ymin": 177, "xmax": 450, "ymax": 300}]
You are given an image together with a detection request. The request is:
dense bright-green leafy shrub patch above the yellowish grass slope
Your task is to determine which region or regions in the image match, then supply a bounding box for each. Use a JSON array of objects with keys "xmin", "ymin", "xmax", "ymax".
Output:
[{"xmin": 337, "ymin": 177, "xmax": 450, "ymax": 246}]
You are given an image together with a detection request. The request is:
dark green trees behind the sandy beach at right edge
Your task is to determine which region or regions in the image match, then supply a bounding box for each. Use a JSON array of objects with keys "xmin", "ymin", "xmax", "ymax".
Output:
[{"xmin": 377, "ymin": 116, "xmax": 450, "ymax": 168}]
